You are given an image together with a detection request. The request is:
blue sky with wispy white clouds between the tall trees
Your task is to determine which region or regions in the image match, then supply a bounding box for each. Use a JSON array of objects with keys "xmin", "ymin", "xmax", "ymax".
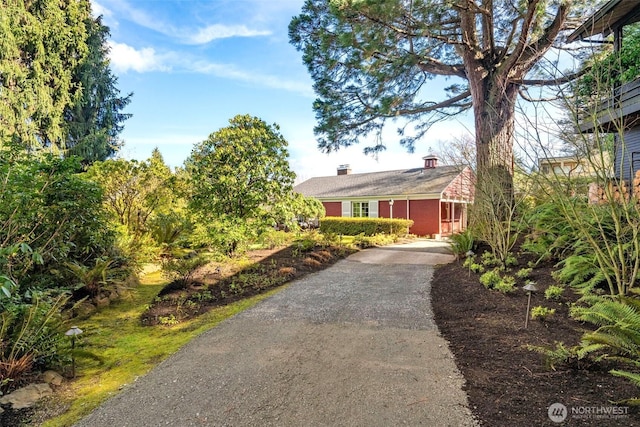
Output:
[{"xmin": 92, "ymin": 0, "xmax": 472, "ymax": 181}]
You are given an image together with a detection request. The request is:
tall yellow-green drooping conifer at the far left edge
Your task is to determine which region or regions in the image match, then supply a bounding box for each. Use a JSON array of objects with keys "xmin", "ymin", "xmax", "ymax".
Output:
[{"xmin": 0, "ymin": 0, "xmax": 90, "ymax": 148}]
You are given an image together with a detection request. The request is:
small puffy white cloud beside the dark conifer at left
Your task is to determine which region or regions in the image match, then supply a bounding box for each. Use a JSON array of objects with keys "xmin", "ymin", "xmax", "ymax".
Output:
[{"xmin": 109, "ymin": 41, "xmax": 172, "ymax": 73}]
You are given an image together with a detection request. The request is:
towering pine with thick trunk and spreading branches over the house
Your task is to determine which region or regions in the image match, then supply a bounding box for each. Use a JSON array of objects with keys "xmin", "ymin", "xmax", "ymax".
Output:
[{"xmin": 289, "ymin": 0, "xmax": 589, "ymax": 196}]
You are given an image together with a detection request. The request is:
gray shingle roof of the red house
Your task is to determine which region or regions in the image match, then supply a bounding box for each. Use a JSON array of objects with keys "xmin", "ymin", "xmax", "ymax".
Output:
[{"xmin": 294, "ymin": 166, "xmax": 462, "ymax": 199}]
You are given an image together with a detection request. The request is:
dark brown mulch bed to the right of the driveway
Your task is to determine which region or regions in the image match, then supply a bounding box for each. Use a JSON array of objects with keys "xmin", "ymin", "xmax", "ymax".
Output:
[{"xmin": 432, "ymin": 252, "xmax": 640, "ymax": 427}]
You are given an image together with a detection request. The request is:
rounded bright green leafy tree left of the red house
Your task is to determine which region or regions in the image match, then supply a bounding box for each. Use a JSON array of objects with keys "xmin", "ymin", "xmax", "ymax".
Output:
[{"xmin": 185, "ymin": 115, "xmax": 295, "ymax": 253}]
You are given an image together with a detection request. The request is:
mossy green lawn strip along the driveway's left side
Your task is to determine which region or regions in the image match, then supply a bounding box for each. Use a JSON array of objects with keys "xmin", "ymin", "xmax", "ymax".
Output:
[{"xmin": 43, "ymin": 272, "xmax": 277, "ymax": 427}]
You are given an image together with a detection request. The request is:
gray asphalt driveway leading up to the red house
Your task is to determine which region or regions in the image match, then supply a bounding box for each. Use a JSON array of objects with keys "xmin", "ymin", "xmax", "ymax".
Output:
[{"xmin": 77, "ymin": 241, "xmax": 475, "ymax": 427}]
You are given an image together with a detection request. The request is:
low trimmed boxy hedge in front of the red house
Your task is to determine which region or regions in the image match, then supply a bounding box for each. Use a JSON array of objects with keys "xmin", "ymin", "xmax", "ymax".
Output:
[{"xmin": 320, "ymin": 216, "xmax": 413, "ymax": 236}]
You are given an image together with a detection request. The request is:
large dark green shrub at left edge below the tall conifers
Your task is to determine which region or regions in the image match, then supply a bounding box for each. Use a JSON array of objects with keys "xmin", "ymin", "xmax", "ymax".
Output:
[{"xmin": 0, "ymin": 155, "xmax": 115, "ymax": 295}]
